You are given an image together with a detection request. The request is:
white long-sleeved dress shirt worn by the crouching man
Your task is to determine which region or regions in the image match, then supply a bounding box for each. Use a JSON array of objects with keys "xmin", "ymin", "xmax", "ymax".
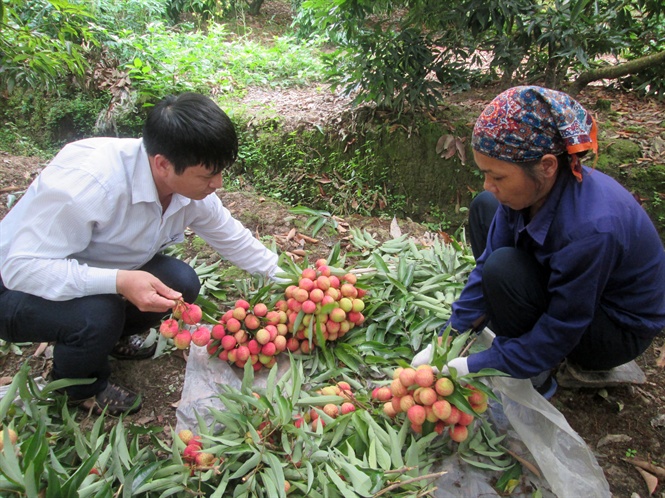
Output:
[{"xmin": 0, "ymin": 138, "xmax": 277, "ymax": 301}]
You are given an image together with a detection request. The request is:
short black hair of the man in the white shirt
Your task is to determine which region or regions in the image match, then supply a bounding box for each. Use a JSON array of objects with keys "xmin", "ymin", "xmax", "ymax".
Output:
[{"xmin": 143, "ymin": 92, "xmax": 238, "ymax": 174}]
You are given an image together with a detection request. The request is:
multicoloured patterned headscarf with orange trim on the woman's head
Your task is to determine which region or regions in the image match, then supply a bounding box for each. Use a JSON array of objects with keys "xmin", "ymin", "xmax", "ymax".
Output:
[{"xmin": 471, "ymin": 86, "xmax": 598, "ymax": 182}]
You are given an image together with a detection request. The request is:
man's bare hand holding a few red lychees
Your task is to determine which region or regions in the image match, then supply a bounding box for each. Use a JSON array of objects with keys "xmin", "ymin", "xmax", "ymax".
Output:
[{"xmin": 115, "ymin": 270, "xmax": 182, "ymax": 312}]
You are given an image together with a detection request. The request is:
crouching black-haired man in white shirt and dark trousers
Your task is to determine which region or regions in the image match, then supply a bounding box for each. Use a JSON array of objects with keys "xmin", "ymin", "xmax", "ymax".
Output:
[{"xmin": 0, "ymin": 93, "xmax": 278, "ymax": 415}]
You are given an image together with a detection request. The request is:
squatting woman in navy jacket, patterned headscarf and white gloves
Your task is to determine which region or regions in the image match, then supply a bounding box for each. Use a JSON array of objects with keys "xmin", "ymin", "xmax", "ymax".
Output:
[{"xmin": 414, "ymin": 86, "xmax": 665, "ymax": 396}]
